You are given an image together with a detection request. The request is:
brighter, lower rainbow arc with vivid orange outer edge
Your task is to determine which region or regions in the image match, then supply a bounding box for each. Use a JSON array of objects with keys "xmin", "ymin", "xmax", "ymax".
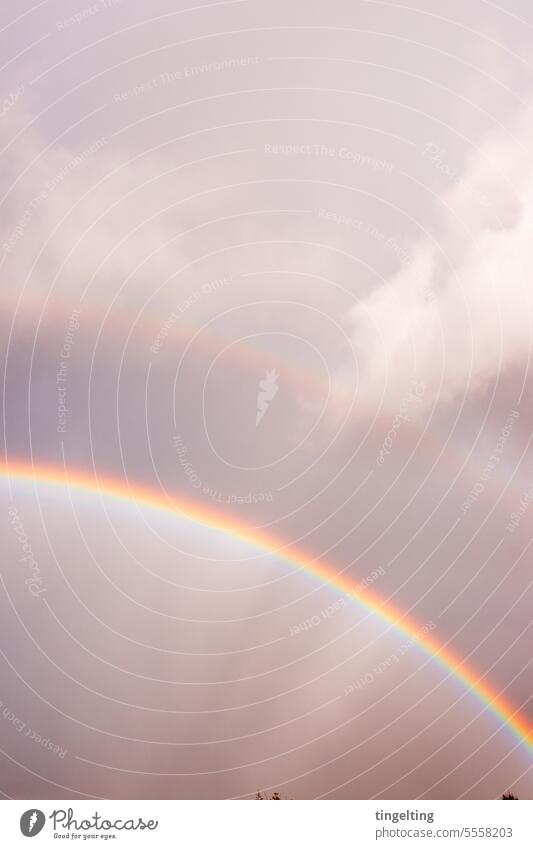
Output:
[{"xmin": 0, "ymin": 461, "xmax": 533, "ymax": 754}]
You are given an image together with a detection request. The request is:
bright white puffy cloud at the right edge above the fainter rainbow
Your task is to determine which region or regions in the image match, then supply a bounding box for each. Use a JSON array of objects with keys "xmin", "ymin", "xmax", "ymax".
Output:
[{"xmin": 349, "ymin": 101, "xmax": 533, "ymax": 412}]
